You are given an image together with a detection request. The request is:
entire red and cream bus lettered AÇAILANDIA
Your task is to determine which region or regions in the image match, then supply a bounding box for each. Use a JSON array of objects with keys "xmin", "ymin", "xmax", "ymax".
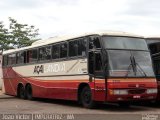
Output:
[{"xmin": 3, "ymin": 32, "xmax": 157, "ymax": 108}]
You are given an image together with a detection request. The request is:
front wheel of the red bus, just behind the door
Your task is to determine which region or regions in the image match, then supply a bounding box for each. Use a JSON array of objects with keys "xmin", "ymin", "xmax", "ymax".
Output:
[{"xmin": 80, "ymin": 86, "xmax": 95, "ymax": 108}]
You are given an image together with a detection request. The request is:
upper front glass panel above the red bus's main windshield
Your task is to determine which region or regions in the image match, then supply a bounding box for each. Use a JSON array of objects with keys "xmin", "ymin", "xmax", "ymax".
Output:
[{"xmin": 102, "ymin": 36, "xmax": 148, "ymax": 50}]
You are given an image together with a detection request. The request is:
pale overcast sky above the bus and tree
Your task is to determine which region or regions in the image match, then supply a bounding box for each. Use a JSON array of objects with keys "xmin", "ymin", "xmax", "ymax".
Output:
[{"xmin": 0, "ymin": 0, "xmax": 160, "ymax": 39}]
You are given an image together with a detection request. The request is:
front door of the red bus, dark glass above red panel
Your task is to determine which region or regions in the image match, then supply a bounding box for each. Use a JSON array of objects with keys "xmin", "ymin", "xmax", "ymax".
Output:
[{"xmin": 89, "ymin": 51, "xmax": 106, "ymax": 101}]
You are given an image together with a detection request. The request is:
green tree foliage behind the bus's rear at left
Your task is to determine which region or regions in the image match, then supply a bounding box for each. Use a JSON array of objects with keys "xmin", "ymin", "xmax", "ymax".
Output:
[{"xmin": 0, "ymin": 17, "xmax": 39, "ymax": 51}]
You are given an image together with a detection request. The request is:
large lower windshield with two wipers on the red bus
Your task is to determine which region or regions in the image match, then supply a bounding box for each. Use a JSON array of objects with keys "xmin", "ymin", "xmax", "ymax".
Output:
[{"xmin": 107, "ymin": 50, "xmax": 154, "ymax": 77}]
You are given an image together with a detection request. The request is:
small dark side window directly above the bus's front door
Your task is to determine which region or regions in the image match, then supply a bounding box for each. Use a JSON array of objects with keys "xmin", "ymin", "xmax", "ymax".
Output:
[{"xmin": 89, "ymin": 37, "xmax": 101, "ymax": 49}]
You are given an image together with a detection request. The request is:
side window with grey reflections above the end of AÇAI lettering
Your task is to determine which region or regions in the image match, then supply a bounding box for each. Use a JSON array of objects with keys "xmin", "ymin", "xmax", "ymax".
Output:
[{"xmin": 39, "ymin": 46, "xmax": 51, "ymax": 61}]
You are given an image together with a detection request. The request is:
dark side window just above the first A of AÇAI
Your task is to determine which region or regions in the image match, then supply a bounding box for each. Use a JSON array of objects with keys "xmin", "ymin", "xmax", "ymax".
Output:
[{"xmin": 28, "ymin": 49, "xmax": 37, "ymax": 62}]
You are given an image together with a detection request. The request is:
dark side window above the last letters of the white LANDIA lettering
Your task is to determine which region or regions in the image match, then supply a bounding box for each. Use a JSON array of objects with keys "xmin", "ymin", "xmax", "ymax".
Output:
[{"xmin": 60, "ymin": 42, "xmax": 67, "ymax": 58}]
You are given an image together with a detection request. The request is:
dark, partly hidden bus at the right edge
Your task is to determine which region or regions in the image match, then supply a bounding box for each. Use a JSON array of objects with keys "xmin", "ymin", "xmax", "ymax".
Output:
[{"xmin": 146, "ymin": 37, "xmax": 160, "ymax": 101}]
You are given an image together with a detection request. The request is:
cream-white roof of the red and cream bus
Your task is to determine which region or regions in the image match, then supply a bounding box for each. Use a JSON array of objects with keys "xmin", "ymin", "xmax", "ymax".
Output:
[{"xmin": 3, "ymin": 31, "xmax": 144, "ymax": 54}]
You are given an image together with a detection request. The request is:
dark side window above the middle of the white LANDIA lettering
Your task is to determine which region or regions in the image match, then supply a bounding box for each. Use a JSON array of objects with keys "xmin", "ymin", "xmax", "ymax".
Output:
[{"xmin": 52, "ymin": 44, "xmax": 60, "ymax": 59}]
